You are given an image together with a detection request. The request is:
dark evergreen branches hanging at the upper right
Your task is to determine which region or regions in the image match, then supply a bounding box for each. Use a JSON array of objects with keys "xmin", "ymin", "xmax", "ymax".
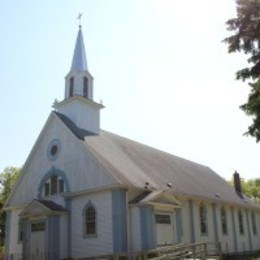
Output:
[{"xmin": 224, "ymin": 0, "xmax": 260, "ymax": 142}]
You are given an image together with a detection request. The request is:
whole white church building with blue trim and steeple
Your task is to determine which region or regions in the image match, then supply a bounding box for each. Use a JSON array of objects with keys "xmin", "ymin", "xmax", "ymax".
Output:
[{"xmin": 5, "ymin": 26, "xmax": 260, "ymax": 260}]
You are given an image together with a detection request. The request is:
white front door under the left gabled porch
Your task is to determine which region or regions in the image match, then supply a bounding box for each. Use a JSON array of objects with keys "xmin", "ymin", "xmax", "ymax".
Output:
[{"xmin": 30, "ymin": 221, "xmax": 46, "ymax": 260}]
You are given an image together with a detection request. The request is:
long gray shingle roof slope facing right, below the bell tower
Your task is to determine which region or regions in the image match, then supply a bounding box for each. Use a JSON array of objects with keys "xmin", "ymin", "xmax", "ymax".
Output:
[{"xmin": 55, "ymin": 112, "xmax": 260, "ymax": 208}]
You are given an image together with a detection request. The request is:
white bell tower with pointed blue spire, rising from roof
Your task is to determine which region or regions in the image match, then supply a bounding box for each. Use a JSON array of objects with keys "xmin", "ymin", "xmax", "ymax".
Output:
[{"xmin": 55, "ymin": 25, "xmax": 103, "ymax": 134}]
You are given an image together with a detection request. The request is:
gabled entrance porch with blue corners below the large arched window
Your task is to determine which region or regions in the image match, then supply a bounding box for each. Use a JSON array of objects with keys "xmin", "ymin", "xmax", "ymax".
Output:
[{"xmin": 17, "ymin": 200, "xmax": 68, "ymax": 260}]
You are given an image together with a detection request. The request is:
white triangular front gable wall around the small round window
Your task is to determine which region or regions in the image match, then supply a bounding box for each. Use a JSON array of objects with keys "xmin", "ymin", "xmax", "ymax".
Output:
[{"xmin": 10, "ymin": 115, "xmax": 114, "ymax": 205}]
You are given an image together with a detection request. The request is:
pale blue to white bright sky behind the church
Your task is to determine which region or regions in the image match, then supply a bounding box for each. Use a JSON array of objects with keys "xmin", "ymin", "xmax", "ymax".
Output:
[{"xmin": 0, "ymin": 0, "xmax": 260, "ymax": 179}]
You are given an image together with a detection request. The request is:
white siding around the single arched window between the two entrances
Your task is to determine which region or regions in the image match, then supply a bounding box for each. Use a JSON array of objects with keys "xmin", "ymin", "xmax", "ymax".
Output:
[{"xmin": 71, "ymin": 191, "xmax": 113, "ymax": 258}]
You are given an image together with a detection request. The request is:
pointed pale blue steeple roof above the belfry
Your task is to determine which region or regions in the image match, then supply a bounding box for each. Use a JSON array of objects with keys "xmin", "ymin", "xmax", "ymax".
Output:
[{"xmin": 70, "ymin": 25, "xmax": 88, "ymax": 71}]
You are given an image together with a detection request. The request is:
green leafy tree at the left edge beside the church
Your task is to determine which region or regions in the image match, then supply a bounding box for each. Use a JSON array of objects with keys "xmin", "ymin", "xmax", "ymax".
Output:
[{"xmin": 0, "ymin": 167, "xmax": 20, "ymax": 248}]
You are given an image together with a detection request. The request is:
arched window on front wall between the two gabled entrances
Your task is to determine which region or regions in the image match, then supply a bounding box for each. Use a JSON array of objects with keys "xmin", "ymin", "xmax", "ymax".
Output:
[{"xmin": 83, "ymin": 201, "xmax": 97, "ymax": 237}]
